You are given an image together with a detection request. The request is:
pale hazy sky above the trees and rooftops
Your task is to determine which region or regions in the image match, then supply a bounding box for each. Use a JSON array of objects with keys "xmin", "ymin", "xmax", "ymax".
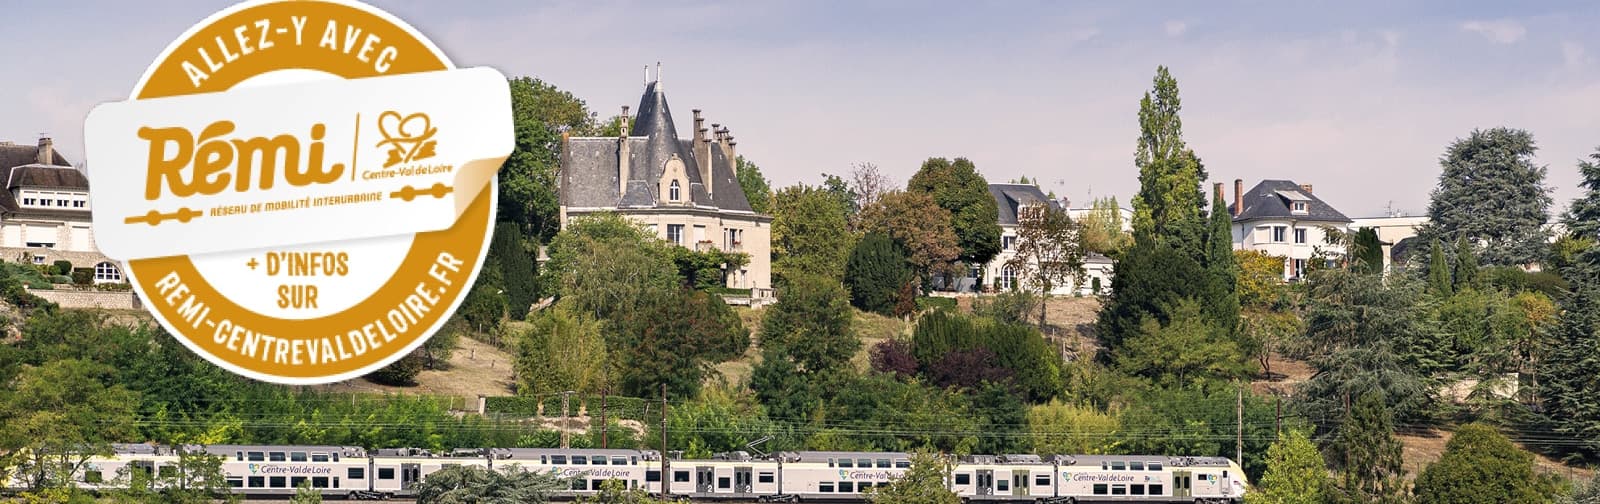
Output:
[{"xmin": 0, "ymin": 0, "xmax": 1600, "ymax": 218}]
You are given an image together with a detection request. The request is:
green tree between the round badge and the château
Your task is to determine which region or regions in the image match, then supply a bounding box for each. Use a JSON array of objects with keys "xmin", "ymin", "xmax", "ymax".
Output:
[{"xmin": 498, "ymin": 77, "xmax": 595, "ymax": 242}]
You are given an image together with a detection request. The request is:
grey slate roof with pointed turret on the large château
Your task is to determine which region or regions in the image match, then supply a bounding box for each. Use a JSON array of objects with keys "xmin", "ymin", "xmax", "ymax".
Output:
[{"xmin": 562, "ymin": 82, "xmax": 752, "ymax": 213}]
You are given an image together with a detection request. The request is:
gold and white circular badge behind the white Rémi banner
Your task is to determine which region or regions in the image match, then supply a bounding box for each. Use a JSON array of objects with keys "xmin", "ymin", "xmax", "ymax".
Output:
[{"xmin": 126, "ymin": 0, "xmax": 496, "ymax": 384}]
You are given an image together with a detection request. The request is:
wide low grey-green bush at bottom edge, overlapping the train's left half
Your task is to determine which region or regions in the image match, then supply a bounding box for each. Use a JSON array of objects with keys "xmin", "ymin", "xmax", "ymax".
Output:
[{"xmin": 416, "ymin": 466, "xmax": 568, "ymax": 504}]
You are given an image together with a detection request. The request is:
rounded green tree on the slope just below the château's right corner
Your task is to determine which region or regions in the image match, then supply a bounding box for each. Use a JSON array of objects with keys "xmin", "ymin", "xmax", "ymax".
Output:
[{"xmin": 762, "ymin": 275, "xmax": 861, "ymax": 374}]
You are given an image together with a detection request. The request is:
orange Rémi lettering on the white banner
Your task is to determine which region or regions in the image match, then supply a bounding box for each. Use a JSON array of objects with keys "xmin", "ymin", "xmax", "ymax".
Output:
[{"xmin": 139, "ymin": 120, "xmax": 344, "ymax": 202}]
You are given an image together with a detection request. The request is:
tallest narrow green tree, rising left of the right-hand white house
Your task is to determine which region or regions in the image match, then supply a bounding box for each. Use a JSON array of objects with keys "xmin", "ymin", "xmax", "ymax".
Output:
[{"xmin": 1133, "ymin": 66, "xmax": 1206, "ymax": 252}]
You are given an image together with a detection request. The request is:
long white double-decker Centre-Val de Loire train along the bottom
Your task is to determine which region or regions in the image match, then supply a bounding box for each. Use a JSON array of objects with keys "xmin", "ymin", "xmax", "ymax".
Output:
[{"xmin": 13, "ymin": 445, "xmax": 1250, "ymax": 504}]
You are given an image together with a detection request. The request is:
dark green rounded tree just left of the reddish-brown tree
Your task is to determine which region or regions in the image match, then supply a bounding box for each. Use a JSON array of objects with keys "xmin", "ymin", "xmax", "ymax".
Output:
[{"xmin": 845, "ymin": 232, "xmax": 914, "ymax": 315}]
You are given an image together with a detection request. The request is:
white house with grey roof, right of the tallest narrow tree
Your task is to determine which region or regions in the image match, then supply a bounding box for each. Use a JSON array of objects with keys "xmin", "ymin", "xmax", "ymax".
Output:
[{"xmin": 1216, "ymin": 179, "xmax": 1350, "ymax": 280}]
